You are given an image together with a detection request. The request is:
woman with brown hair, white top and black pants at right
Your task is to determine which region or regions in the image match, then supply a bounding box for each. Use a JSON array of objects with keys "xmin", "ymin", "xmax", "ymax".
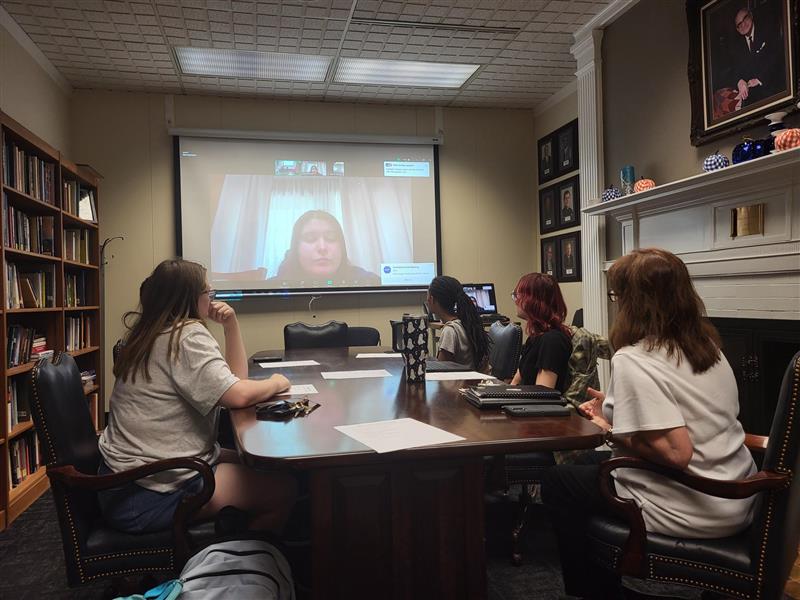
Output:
[{"xmin": 542, "ymin": 248, "xmax": 755, "ymax": 598}]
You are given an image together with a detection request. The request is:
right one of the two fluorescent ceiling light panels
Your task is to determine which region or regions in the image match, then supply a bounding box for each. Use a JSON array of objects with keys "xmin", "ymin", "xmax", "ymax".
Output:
[{"xmin": 333, "ymin": 58, "xmax": 480, "ymax": 88}]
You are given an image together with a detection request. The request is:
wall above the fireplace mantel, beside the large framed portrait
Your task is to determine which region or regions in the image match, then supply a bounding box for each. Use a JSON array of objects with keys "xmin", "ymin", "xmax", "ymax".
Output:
[{"xmin": 603, "ymin": 0, "xmax": 800, "ymax": 186}]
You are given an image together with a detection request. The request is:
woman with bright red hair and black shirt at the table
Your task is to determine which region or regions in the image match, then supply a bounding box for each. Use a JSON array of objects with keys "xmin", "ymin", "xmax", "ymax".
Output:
[{"xmin": 511, "ymin": 273, "xmax": 572, "ymax": 392}]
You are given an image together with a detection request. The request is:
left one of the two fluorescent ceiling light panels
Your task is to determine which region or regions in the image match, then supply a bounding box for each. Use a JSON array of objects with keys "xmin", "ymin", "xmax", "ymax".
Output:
[{"xmin": 175, "ymin": 48, "xmax": 331, "ymax": 81}]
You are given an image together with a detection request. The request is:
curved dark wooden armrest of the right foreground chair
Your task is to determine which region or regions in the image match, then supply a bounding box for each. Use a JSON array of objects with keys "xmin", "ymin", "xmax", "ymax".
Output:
[{"xmin": 598, "ymin": 456, "xmax": 791, "ymax": 577}]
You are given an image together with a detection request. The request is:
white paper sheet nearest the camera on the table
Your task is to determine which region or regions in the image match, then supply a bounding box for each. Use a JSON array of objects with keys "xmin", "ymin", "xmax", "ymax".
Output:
[{"xmin": 334, "ymin": 419, "xmax": 464, "ymax": 453}]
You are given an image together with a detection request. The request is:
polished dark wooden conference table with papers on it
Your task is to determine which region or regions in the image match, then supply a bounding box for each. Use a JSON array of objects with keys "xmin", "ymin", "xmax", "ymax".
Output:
[{"xmin": 231, "ymin": 347, "xmax": 602, "ymax": 600}]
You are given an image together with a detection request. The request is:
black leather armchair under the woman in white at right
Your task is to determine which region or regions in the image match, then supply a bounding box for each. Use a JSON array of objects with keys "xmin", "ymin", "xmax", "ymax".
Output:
[{"xmin": 589, "ymin": 352, "xmax": 800, "ymax": 600}]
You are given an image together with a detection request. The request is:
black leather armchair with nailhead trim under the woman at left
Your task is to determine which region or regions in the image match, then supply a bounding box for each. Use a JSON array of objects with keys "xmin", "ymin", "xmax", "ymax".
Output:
[{"xmin": 30, "ymin": 353, "xmax": 214, "ymax": 586}]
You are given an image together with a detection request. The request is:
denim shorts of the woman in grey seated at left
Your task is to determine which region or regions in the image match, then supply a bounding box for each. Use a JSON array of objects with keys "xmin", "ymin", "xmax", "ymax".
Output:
[{"xmin": 97, "ymin": 462, "xmax": 216, "ymax": 533}]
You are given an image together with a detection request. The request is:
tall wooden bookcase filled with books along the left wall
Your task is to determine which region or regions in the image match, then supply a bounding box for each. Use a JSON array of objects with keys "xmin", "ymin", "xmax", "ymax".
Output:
[{"xmin": 0, "ymin": 113, "xmax": 104, "ymax": 530}]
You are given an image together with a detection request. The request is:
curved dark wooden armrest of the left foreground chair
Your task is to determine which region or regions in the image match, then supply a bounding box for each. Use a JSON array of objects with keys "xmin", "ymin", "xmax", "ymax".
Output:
[{"xmin": 47, "ymin": 456, "xmax": 216, "ymax": 568}]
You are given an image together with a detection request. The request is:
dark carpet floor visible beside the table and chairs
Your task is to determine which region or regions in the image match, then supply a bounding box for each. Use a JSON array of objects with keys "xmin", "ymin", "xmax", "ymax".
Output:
[{"xmin": 0, "ymin": 492, "xmax": 697, "ymax": 600}]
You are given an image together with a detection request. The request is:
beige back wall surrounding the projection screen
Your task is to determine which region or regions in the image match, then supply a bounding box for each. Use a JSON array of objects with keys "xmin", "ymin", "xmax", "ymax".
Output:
[{"xmin": 72, "ymin": 91, "xmax": 537, "ymax": 398}]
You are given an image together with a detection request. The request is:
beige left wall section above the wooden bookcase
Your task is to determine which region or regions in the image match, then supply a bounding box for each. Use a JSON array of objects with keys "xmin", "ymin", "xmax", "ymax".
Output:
[{"xmin": 0, "ymin": 27, "xmax": 72, "ymax": 158}]
